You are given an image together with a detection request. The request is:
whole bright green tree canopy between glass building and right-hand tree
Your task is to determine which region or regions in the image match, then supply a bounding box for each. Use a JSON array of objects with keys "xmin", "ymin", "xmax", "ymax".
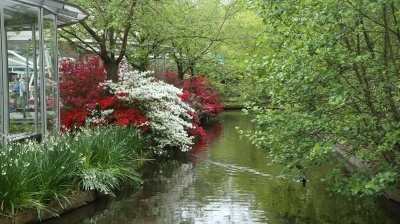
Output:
[{"xmin": 59, "ymin": 0, "xmax": 260, "ymax": 105}]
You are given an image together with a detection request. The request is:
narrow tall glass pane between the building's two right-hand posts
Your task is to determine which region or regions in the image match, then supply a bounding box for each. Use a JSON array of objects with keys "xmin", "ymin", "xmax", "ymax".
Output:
[{"xmin": 43, "ymin": 10, "xmax": 58, "ymax": 134}]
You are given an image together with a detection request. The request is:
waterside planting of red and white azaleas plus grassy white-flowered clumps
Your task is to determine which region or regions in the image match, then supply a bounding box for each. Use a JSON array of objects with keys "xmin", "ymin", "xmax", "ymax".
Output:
[{"xmin": 0, "ymin": 57, "xmax": 222, "ymax": 223}]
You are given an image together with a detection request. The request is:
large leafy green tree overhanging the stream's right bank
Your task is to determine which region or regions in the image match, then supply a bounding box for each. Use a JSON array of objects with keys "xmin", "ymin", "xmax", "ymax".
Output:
[{"xmin": 242, "ymin": 0, "xmax": 400, "ymax": 196}]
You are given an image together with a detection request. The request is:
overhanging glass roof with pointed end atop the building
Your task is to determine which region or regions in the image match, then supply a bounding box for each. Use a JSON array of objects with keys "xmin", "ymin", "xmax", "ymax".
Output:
[{"xmin": 0, "ymin": 0, "xmax": 88, "ymax": 28}]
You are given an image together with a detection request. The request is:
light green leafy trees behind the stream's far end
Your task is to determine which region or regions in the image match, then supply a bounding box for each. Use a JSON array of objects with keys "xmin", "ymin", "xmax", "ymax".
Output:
[{"xmin": 136, "ymin": 0, "xmax": 264, "ymax": 105}]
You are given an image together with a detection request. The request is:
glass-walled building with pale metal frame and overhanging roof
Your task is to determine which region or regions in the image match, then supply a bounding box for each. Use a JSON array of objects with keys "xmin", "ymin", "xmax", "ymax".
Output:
[{"xmin": 0, "ymin": 0, "xmax": 87, "ymax": 144}]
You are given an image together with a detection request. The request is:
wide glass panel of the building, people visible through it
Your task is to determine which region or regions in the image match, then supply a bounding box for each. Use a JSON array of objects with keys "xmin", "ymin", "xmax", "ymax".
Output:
[{"xmin": 4, "ymin": 1, "xmax": 39, "ymax": 138}]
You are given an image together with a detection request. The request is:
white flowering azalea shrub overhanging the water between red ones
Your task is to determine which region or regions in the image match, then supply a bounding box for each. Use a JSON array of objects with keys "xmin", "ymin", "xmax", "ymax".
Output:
[{"xmin": 101, "ymin": 71, "xmax": 194, "ymax": 153}]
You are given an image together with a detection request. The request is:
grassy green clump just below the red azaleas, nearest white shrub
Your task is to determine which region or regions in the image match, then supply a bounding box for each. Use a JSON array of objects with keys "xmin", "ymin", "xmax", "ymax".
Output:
[{"xmin": 70, "ymin": 126, "xmax": 144, "ymax": 196}]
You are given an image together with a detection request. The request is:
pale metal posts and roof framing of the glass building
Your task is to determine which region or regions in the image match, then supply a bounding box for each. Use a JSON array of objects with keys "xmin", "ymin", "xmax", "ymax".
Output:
[{"xmin": 0, "ymin": 0, "xmax": 88, "ymax": 145}]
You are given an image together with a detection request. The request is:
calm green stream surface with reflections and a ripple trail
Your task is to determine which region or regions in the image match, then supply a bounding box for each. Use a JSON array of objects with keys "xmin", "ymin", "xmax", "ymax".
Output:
[{"xmin": 46, "ymin": 111, "xmax": 400, "ymax": 224}]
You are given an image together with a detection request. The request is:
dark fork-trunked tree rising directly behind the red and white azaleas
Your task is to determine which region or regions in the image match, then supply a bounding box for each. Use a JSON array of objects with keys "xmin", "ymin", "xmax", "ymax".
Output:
[{"xmin": 60, "ymin": 0, "xmax": 138, "ymax": 81}]
